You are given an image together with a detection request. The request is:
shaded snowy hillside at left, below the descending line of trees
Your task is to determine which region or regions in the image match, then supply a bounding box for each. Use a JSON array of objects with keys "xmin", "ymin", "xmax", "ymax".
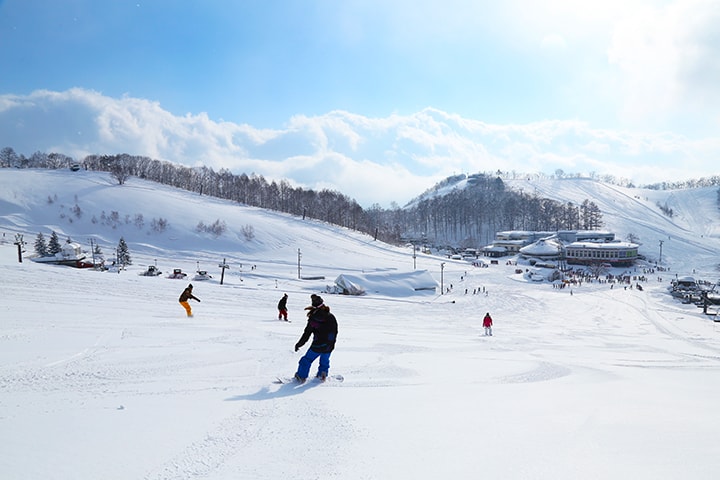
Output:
[{"xmin": 0, "ymin": 169, "xmax": 412, "ymax": 276}]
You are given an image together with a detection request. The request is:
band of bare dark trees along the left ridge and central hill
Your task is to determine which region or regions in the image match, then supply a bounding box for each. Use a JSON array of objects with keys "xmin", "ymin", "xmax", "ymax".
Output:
[{"xmin": 0, "ymin": 147, "xmax": 716, "ymax": 248}]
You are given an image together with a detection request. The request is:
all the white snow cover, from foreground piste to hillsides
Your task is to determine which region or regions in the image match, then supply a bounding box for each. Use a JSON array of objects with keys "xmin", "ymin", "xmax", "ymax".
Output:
[{"xmin": 0, "ymin": 169, "xmax": 720, "ymax": 480}]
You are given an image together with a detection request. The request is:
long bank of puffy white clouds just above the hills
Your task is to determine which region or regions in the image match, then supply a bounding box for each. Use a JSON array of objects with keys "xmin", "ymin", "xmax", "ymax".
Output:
[{"xmin": 0, "ymin": 89, "xmax": 720, "ymax": 207}]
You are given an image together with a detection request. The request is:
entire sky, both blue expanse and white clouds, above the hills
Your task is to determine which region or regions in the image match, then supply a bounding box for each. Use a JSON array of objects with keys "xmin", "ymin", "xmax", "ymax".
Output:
[{"xmin": 0, "ymin": 0, "xmax": 720, "ymax": 205}]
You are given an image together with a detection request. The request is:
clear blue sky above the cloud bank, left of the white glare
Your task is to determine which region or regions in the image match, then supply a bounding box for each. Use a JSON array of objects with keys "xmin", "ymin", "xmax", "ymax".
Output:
[{"xmin": 0, "ymin": 0, "xmax": 572, "ymax": 127}]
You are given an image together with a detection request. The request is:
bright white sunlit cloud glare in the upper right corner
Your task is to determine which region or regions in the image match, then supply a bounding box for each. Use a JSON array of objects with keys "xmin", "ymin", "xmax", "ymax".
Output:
[{"xmin": 608, "ymin": 0, "xmax": 720, "ymax": 127}]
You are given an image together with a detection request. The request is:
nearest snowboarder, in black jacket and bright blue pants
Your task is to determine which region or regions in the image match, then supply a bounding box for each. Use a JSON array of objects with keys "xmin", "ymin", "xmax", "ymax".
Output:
[{"xmin": 295, "ymin": 294, "xmax": 338, "ymax": 383}]
